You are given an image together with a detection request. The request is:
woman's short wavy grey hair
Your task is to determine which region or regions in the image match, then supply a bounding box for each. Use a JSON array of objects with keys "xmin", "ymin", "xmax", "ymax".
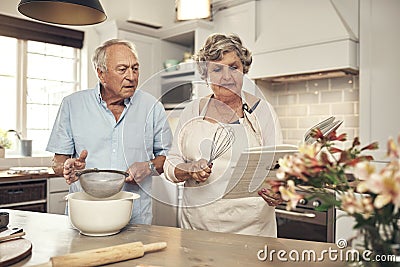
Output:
[{"xmin": 193, "ymin": 33, "xmax": 253, "ymax": 80}]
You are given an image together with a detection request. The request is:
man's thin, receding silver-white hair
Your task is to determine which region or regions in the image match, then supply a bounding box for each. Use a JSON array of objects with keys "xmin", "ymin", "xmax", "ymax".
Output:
[{"xmin": 92, "ymin": 39, "xmax": 139, "ymax": 72}]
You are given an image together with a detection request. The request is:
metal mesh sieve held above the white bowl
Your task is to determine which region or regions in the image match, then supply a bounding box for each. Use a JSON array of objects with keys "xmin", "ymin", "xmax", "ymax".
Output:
[{"xmin": 76, "ymin": 169, "xmax": 129, "ymax": 198}]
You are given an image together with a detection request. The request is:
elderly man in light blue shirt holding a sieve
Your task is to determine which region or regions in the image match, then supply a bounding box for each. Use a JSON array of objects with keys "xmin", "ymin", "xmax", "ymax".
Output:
[{"xmin": 47, "ymin": 39, "xmax": 172, "ymax": 224}]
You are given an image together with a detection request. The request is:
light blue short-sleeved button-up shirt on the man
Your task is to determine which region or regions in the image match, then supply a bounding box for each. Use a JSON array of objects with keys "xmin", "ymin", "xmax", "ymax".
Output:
[{"xmin": 46, "ymin": 84, "xmax": 172, "ymax": 224}]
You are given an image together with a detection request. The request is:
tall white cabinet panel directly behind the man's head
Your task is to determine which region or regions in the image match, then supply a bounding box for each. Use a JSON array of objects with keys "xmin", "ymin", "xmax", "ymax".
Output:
[{"xmin": 119, "ymin": 30, "xmax": 161, "ymax": 98}]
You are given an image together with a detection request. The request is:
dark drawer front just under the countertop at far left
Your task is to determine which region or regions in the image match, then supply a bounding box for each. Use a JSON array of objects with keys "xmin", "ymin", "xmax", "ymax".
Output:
[{"xmin": 0, "ymin": 180, "xmax": 46, "ymax": 204}]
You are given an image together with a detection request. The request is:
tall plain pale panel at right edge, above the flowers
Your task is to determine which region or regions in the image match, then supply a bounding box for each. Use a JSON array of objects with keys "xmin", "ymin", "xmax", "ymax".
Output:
[{"xmin": 360, "ymin": 0, "xmax": 400, "ymax": 160}]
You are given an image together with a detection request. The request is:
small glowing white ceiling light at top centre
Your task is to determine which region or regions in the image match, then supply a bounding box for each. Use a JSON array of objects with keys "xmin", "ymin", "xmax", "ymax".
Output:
[{"xmin": 175, "ymin": 0, "xmax": 211, "ymax": 20}]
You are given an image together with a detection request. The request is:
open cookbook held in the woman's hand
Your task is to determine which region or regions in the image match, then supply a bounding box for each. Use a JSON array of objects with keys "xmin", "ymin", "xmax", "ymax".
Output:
[{"xmin": 223, "ymin": 117, "xmax": 343, "ymax": 199}]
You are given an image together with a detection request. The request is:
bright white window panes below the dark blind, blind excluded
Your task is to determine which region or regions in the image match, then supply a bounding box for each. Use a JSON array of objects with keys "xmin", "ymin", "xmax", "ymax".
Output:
[{"xmin": 0, "ymin": 36, "xmax": 79, "ymax": 156}]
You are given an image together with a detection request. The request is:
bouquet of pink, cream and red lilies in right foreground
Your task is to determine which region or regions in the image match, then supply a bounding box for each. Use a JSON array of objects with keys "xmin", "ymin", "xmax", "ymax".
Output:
[{"xmin": 269, "ymin": 129, "xmax": 400, "ymax": 262}]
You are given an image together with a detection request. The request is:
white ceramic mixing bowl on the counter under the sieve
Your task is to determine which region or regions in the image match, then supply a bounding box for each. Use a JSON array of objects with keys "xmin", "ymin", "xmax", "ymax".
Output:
[{"xmin": 67, "ymin": 191, "xmax": 140, "ymax": 236}]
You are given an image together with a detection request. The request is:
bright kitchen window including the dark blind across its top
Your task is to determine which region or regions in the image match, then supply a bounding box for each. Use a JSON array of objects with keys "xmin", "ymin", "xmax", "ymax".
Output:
[{"xmin": 0, "ymin": 15, "xmax": 83, "ymax": 155}]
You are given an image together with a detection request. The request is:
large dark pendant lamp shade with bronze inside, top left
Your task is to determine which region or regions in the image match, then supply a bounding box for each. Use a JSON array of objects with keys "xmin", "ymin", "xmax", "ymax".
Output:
[{"xmin": 18, "ymin": 0, "xmax": 107, "ymax": 25}]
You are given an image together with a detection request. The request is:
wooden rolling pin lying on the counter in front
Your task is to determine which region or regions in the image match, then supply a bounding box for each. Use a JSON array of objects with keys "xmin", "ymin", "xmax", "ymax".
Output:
[{"xmin": 32, "ymin": 242, "xmax": 167, "ymax": 267}]
